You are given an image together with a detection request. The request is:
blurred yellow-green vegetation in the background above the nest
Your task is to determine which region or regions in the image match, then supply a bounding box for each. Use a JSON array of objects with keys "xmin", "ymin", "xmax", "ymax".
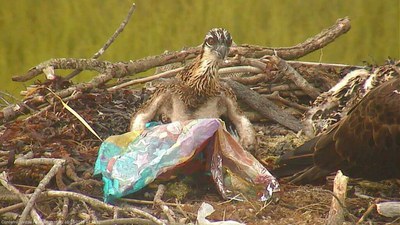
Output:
[{"xmin": 0, "ymin": 0, "xmax": 400, "ymax": 95}]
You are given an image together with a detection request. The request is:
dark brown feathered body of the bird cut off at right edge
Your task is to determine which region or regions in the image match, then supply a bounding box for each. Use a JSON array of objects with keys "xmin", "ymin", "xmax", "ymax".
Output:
[{"xmin": 271, "ymin": 77, "xmax": 400, "ymax": 184}]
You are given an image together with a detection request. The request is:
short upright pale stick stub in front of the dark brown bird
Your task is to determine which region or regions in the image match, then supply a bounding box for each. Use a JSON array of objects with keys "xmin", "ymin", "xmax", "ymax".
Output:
[{"xmin": 327, "ymin": 170, "xmax": 349, "ymax": 225}]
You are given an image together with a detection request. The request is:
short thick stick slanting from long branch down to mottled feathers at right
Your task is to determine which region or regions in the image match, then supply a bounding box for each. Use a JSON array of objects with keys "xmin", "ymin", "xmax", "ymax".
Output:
[{"xmin": 268, "ymin": 56, "xmax": 321, "ymax": 99}]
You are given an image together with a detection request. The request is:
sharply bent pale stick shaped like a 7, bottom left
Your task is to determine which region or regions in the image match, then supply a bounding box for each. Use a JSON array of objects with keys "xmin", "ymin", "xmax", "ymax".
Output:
[{"xmin": 15, "ymin": 159, "xmax": 65, "ymax": 225}]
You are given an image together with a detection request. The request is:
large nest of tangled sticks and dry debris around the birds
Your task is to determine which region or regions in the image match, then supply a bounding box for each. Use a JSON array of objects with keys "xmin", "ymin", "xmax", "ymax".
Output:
[{"xmin": 0, "ymin": 9, "xmax": 400, "ymax": 224}]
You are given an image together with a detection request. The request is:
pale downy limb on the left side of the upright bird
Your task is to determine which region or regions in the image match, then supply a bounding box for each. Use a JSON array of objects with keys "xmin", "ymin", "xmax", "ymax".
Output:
[{"xmin": 129, "ymin": 94, "xmax": 166, "ymax": 131}]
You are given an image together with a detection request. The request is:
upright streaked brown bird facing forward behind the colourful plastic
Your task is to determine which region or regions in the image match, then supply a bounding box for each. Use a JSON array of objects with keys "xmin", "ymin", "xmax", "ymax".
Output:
[{"xmin": 130, "ymin": 28, "xmax": 255, "ymax": 149}]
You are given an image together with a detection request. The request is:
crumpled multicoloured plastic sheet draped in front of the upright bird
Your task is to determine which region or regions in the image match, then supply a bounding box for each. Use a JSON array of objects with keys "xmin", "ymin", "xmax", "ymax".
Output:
[{"xmin": 94, "ymin": 118, "xmax": 279, "ymax": 202}]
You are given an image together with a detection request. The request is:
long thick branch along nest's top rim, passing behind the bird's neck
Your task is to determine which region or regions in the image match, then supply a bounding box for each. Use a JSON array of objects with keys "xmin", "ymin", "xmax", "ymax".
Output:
[{"xmin": 12, "ymin": 18, "xmax": 350, "ymax": 82}]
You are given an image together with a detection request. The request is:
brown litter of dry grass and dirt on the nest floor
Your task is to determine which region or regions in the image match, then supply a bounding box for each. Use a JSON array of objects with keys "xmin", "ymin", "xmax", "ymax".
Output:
[{"xmin": 0, "ymin": 87, "xmax": 400, "ymax": 224}]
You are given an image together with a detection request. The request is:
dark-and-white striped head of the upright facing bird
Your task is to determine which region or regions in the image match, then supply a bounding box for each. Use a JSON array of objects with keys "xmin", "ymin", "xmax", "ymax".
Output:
[{"xmin": 203, "ymin": 28, "xmax": 232, "ymax": 60}]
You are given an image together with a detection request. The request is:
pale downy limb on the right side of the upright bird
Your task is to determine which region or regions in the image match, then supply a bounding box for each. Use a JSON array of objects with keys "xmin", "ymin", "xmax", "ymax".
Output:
[{"xmin": 225, "ymin": 98, "xmax": 256, "ymax": 151}]
